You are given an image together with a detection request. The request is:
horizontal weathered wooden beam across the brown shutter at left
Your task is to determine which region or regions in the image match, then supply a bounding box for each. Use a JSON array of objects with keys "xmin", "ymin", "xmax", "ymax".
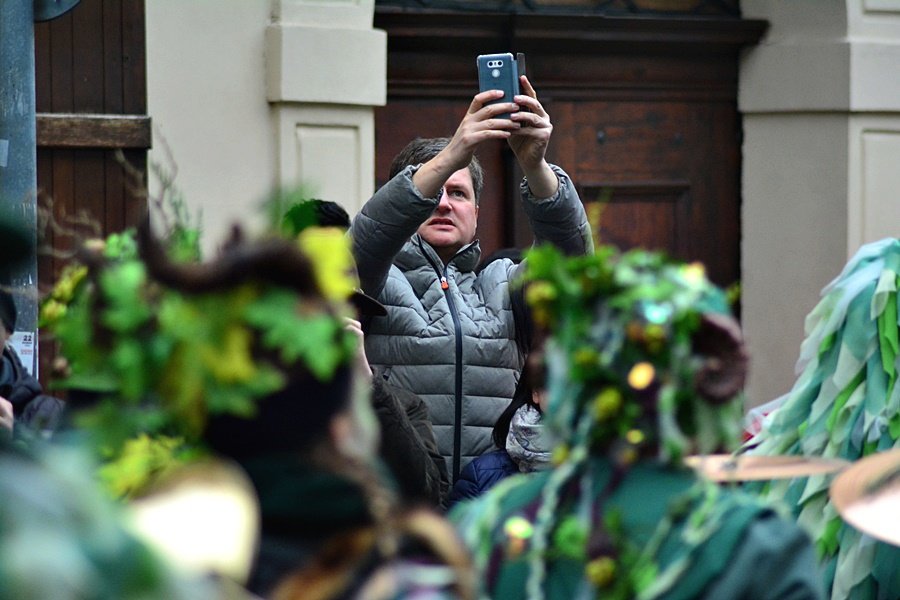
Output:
[{"xmin": 37, "ymin": 113, "xmax": 151, "ymax": 150}]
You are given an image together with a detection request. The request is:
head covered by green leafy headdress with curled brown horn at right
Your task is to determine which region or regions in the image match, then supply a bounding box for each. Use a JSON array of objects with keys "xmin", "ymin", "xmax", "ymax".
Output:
[{"xmin": 526, "ymin": 248, "xmax": 747, "ymax": 464}]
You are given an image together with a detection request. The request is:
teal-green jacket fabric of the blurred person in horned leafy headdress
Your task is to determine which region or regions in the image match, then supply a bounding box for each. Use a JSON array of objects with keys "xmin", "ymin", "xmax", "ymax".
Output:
[{"xmin": 450, "ymin": 458, "xmax": 823, "ymax": 600}]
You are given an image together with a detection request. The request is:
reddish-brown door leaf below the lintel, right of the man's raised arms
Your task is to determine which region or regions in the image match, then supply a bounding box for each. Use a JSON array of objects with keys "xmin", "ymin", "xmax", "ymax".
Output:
[{"xmin": 555, "ymin": 101, "xmax": 740, "ymax": 284}]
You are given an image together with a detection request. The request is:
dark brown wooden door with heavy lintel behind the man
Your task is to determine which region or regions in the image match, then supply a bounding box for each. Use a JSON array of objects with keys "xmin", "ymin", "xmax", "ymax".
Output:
[{"xmin": 375, "ymin": 5, "xmax": 765, "ymax": 285}]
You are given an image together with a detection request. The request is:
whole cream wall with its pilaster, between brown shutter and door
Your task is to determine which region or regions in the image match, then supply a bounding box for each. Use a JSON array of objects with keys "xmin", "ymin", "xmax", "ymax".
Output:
[{"xmin": 146, "ymin": 0, "xmax": 387, "ymax": 250}]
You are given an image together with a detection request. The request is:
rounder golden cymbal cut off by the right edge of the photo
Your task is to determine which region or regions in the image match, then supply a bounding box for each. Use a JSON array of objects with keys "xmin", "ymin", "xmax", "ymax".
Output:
[{"xmin": 828, "ymin": 449, "xmax": 900, "ymax": 546}]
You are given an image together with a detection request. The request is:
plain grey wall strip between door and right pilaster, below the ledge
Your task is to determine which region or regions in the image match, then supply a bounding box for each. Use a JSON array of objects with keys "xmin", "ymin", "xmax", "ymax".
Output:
[{"xmin": 741, "ymin": 113, "xmax": 848, "ymax": 406}]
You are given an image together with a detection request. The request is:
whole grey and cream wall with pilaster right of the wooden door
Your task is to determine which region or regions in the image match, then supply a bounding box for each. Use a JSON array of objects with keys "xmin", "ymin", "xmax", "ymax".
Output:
[{"xmin": 739, "ymin": 0, "xmax": 900, "ymax": 405}]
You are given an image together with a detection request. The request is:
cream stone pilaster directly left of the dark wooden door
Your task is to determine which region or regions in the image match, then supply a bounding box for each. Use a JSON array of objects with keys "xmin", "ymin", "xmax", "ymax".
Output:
[{"xmin": 266, "ymin": 0, "xmax": 387, "ymax": 214}]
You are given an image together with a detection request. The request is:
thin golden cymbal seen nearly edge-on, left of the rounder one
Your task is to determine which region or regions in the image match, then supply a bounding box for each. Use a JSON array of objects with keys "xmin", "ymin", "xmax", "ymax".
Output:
[{"xmin": 684, "ymin": 454, "xmax": 850, "ymax": 482}]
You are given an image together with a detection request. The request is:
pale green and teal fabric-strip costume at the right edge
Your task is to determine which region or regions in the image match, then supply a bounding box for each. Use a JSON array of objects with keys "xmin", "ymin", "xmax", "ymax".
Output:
[{"xmin": 752, "ymin": 238, "xmax": 900, "ymax": 600}]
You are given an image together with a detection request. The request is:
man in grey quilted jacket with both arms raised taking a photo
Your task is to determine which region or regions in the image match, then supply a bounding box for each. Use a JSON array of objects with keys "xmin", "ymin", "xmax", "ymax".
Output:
[{"xmin": 350, "ymin": 75, "xmax": 593, "ymax": 480}]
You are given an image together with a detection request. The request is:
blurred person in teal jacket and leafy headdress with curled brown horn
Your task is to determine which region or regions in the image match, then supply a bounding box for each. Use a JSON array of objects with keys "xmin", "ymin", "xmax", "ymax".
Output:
[{"xmin": 450, "ymin": 247, "xmax": 822, "ymax": 600}]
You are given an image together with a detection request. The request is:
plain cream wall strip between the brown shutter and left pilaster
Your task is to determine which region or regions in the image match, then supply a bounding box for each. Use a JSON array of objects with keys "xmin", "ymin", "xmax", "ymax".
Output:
[{"xmin": 146, "ymin": 0, "xmax": 276, "ymax": 247}]
